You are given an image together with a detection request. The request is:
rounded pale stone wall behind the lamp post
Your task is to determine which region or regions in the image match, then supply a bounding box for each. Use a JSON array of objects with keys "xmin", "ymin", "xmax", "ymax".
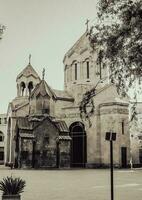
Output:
[{"xmin": 100, "ymin": 104, "xmax": 130, "ymax": 167}]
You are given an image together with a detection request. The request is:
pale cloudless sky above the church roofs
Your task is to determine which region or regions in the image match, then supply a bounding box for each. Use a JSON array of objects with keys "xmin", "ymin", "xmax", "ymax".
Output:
[{"xmin": 0, "ymin": 0, "xmax": 97, "ymax": 113}]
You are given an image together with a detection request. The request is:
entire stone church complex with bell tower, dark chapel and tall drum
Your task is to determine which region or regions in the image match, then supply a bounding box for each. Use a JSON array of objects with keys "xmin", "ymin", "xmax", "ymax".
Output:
[{"xmin": 6, "ymin": 32, "xmax": 130, "ymax": 168}]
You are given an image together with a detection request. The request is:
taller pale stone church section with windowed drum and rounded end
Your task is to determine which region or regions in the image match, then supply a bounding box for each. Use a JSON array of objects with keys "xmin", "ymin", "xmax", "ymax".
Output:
[{"xmin": 61, "ymin": 31, "xmax": 130, "ymax": 167}]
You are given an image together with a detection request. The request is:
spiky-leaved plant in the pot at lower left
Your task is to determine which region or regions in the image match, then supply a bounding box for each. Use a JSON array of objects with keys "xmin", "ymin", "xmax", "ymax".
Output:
[{"xmin": 0, "ymin": 176, "xmax": 26, "ymax": 195}]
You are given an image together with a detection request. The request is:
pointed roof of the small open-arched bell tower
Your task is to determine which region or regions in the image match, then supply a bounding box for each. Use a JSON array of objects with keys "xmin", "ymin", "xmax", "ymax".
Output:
[{"xmin": 17, "ymin": 63, "xmax": 40, "ymax": 79}]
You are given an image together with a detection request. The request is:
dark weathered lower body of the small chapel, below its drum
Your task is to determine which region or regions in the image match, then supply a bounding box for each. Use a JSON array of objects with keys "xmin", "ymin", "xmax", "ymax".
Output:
[{"xmin": 15, "ymin": 116, "xmax": 70, "ymax": 168}]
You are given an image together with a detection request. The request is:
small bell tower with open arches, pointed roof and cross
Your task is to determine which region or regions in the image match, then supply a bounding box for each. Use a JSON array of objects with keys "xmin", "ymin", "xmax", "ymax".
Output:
[{"xmin": 16, "ymin": 55, "xmax": 40, "ymax": 97}]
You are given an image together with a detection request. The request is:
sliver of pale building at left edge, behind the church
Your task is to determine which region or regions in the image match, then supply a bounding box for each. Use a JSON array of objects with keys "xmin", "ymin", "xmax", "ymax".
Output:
[{"xmin": 0, "ymin": 114, "xmax": 7, "ymax": 164}]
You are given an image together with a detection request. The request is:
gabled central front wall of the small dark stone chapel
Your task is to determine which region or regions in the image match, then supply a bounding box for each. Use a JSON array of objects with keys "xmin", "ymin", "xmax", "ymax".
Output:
[{"xmin": 33, "ymin": 119, "xmax": 59, "ymax": 167}]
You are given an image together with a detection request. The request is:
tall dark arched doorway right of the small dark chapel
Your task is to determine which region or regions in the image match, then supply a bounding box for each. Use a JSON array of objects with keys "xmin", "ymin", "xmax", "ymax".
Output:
[{"xmin": 70, "ymin": 122, "xmax": 87, "ymax": 167}]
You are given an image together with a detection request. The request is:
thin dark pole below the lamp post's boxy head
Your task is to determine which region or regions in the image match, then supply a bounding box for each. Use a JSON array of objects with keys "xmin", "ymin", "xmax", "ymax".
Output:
[{"xmin": 110, "ymin": 140, "xmax": 114, "ymax": 200}]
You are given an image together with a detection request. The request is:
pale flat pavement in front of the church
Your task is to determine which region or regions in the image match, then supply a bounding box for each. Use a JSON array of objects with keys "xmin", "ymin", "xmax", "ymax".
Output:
[{"xmin": 0, "ymin": 168, "xmax": 142, "ymax": 200}]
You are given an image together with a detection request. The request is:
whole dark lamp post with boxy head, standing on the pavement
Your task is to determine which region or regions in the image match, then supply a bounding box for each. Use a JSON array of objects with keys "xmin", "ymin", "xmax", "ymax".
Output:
[{"xmin": 105, "ymin": 131, "xmax": 116, "ymax": 200}]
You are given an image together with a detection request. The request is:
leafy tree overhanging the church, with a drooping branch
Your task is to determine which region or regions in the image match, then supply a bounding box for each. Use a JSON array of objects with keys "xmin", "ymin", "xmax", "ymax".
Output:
[{"xmin": 80, "ymin": 0, "xmax": 142, "ymax": 122}]
